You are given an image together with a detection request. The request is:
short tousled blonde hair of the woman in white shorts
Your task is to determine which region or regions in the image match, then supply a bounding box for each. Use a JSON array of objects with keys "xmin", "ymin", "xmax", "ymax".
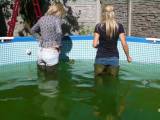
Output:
[{"xmin": 45, "ymin": 3, "xmax": 65, "ymax": 17}]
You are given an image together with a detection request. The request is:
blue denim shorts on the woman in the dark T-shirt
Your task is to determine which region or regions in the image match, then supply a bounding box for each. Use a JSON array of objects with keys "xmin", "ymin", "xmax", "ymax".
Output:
[{"xmin": 95, "ymin": 57, "xmax": 119, "ymax": 67}]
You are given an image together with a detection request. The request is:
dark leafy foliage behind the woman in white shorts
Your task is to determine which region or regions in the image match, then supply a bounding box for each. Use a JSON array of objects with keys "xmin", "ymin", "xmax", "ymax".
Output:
[{"xmin": 0, "ymin": 0, "xmax": 100, "ymax": 35}]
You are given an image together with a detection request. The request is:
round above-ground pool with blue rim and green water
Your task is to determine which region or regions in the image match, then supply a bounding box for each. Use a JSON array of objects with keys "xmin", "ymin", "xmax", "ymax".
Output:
[{"xmin": 0, "ymin": 36, "xmax": 160, "ymax": 120}]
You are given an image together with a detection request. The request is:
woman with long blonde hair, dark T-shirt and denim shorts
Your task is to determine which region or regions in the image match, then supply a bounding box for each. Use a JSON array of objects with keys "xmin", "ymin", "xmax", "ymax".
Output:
[{"xmin": 93, "ymin": 5, "xmax": 132, "ymax": 77}]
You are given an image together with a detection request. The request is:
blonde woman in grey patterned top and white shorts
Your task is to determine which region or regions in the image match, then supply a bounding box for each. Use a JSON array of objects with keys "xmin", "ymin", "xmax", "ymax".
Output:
[{"xmin": 31, "ymin": 3, "xmax": 64, "ymax": 69}]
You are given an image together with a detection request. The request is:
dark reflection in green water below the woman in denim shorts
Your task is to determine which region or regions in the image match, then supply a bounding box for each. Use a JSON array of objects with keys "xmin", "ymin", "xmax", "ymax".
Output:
[{"xmin": 94, "ymin": 75, "xmax": 120, "ymax": 120}]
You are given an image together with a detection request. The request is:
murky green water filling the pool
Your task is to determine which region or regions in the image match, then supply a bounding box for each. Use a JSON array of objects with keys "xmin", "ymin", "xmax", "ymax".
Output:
[{"xmin": 0, "ymin": 60, "xmax": 160, "ymax": 120}]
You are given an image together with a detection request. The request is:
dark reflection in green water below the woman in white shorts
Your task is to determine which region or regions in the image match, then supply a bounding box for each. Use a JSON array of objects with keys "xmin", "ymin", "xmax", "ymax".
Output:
[{"xmin": 35, "ymin": 64, "xmax": 72, "ymax": 120}]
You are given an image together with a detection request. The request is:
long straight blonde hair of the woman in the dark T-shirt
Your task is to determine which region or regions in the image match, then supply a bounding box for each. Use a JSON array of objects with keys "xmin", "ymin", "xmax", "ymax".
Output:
[{"xmin": 102, "ymin": 5, "xmax": 118, "ymax": 38}]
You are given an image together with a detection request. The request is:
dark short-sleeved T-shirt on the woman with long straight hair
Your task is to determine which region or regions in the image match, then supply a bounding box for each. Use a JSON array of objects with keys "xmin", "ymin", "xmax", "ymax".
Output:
[{"xmin": 95, "ymin": 23, "xmax": 124, "ymax": 58}]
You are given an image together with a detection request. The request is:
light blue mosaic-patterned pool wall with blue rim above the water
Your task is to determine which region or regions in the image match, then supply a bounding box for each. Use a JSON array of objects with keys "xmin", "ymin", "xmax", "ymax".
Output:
[{"xmin": 0, "ymin": 36, "xmax": 160, "ymax": 65}]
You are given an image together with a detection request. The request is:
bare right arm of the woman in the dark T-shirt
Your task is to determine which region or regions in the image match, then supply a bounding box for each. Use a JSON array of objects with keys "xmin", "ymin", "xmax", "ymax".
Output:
[{"xmin": 119, "ymin": 33, "xmax": 132, "ymax": 62}]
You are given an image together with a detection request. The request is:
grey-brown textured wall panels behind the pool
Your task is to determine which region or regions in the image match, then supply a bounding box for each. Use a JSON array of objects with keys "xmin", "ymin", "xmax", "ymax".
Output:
[{"xmin": 68, "ymin": 0, "xmax": 160, "ymax": 38}]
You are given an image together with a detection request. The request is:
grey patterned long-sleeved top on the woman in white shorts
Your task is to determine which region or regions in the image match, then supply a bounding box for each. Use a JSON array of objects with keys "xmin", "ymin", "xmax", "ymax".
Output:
[{"xmin": 32, "ymin": 15, "xmax": 62, "ymax": 48}]
